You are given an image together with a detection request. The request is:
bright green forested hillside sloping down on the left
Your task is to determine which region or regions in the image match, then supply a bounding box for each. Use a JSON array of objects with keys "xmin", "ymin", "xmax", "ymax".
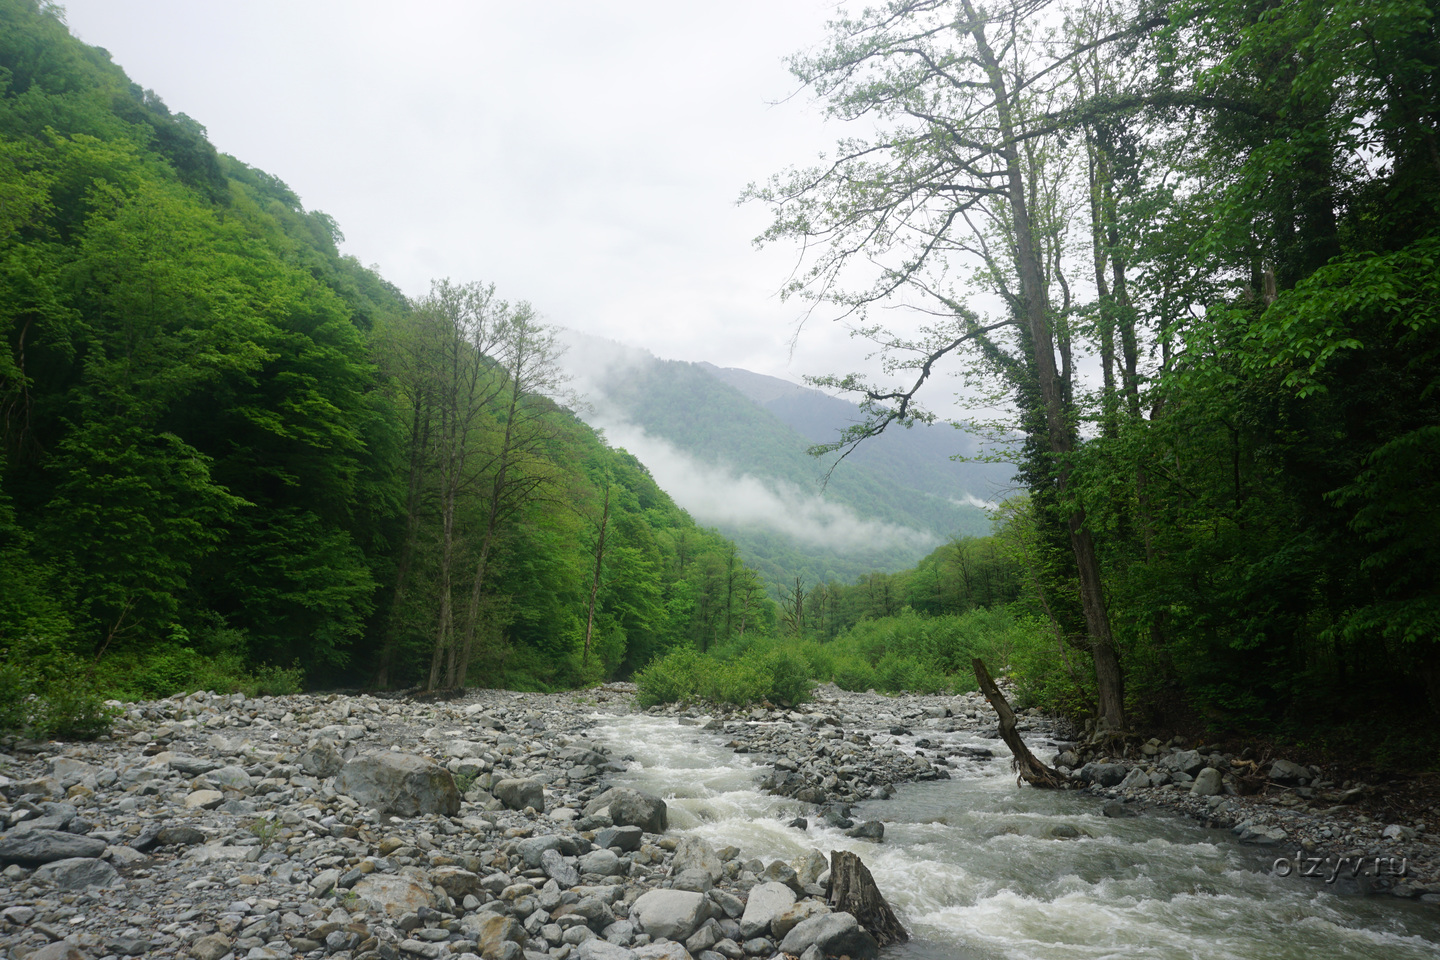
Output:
[{"xmin": 0, "ymin": 0, "xmax": 773, "ymax": 725}]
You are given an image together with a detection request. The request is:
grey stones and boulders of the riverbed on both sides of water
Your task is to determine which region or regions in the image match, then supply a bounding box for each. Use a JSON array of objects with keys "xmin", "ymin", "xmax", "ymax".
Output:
[{"xmin": 0, "ymin": 688, "xmax": 1440, "ymax": 960}]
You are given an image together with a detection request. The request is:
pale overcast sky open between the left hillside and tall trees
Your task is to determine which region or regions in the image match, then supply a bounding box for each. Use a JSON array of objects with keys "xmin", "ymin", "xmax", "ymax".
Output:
[{"xmin": 62, "ymin": 0, "xmax": 887, "ymax": 391}]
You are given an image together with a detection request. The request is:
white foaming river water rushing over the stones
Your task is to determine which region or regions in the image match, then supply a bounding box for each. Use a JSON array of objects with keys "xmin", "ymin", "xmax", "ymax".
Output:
[{"xmin": 593, "ymin": 714, "xmax": 1440, "ymax": 960}]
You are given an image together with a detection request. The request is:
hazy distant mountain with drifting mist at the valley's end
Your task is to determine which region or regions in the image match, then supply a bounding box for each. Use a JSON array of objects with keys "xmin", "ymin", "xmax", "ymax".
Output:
[{"xmin": 555, "ymin": 332, "xmax": 1008, "ymax": 586}]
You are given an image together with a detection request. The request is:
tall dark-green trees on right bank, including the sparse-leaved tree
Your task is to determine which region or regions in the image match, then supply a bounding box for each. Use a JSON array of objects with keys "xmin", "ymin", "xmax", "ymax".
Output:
[{"xmin": 747, "ymin": 0, "xmax": 1440, "ymax": 761}]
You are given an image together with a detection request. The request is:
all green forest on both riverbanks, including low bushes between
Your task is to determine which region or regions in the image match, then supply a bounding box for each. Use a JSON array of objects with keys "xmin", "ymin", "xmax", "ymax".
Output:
[{"xmin": 0, "ymin": 0, "xmax": 1440, "ymax": 766}]
